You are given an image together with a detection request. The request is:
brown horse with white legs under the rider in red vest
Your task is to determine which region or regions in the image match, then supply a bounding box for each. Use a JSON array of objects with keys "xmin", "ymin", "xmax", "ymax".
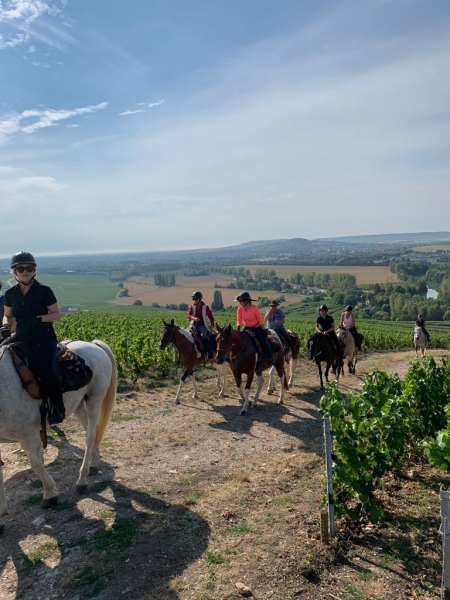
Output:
[{"xmin": 159, "ymin": 319, "xmax": 227, "ymax": 404}]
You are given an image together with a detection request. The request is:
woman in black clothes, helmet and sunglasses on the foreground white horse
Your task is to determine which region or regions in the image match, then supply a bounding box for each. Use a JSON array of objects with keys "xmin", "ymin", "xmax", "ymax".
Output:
[{"xmin": 5, "ymin": 250, "xmax": 65, "ymax": 425}]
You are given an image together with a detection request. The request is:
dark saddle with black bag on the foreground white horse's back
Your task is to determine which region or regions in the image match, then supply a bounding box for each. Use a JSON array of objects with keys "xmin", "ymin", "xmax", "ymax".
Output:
[{"xmin": 8, "ymin": 342, "xmax": 93, "ymax": 400}]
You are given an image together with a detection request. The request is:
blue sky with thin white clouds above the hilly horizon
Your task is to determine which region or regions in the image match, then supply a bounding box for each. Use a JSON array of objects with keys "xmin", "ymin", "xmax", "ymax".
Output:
[{"xmin": 0, "ymin": 0, "xmax": 450, "ymax": 256}]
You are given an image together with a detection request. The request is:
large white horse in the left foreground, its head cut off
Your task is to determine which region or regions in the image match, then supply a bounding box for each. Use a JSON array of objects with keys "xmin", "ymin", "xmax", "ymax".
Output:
[{"xmin": 0, "ymin": 340, "xmax": 117, "ymax": 534}]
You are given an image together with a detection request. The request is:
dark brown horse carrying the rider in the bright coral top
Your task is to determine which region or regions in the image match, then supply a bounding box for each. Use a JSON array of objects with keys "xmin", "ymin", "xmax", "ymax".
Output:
[{"xmin": 216, "ymin": 325, "xmax": 288, "ymax": 416}]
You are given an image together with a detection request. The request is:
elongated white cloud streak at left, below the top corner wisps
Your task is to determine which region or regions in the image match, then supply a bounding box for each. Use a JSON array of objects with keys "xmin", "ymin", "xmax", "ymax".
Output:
[{"xmin": 0, "ymin": 102, "xmax": 108, "ymax": 143}]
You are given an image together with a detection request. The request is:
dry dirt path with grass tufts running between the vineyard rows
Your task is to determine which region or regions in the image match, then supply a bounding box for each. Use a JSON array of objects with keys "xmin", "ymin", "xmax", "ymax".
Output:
[{"xmin": 0, "ymin": 351, "xmax": 444, "ymax": 600}]
